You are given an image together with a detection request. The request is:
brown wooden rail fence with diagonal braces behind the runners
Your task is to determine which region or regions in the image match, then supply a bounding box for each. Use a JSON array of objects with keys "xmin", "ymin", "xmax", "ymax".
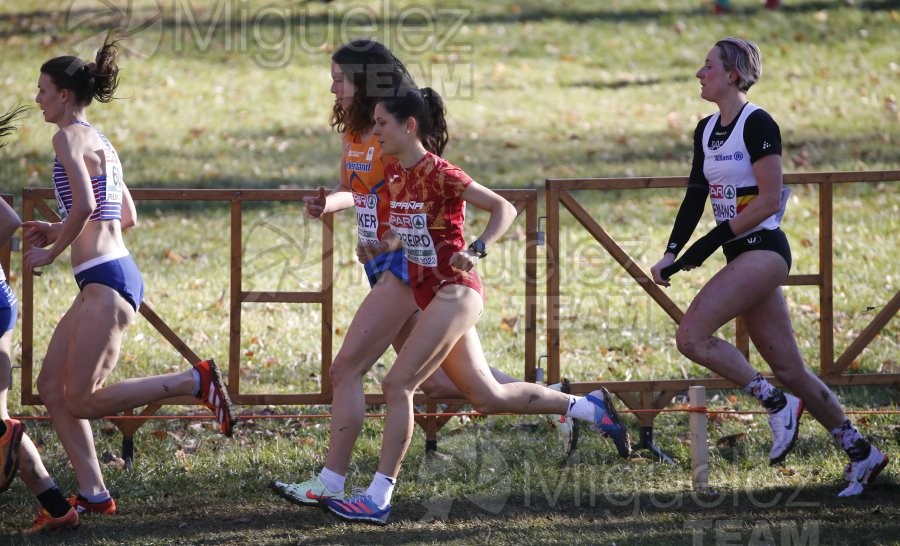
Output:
[{"xmin": 8, "ymin": 171, "xmax": 900, "ymax": 449}]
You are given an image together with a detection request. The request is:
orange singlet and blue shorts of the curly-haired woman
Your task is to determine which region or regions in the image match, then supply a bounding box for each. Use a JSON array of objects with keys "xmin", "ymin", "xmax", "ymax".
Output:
[{"xmin": 341, "ymin": 134, "xmax": 409, "ymax": 286}]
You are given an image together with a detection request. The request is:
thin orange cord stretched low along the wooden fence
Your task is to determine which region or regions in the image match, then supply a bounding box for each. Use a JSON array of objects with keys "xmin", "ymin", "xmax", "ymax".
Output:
[{"xmin": 13, "ymin": 406, "xmax": 900, "ymax": 421}]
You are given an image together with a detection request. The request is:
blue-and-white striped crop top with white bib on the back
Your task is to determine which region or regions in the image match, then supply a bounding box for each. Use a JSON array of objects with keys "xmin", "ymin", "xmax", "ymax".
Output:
[{"xmin": 53, "ymin": 121, "xmax": 125, "ymax": 222}]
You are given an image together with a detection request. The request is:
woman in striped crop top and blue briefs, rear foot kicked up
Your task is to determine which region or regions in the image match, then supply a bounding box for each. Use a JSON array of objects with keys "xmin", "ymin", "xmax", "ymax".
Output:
[{"xmin": 23, "ymin": 38, "xmax": 234, "ymax": 524}]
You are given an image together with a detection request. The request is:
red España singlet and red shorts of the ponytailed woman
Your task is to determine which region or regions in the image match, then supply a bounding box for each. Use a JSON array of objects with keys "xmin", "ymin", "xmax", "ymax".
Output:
[{"xmin": 384, "ymin": 152, "xmax": 484, "ymax": 309}]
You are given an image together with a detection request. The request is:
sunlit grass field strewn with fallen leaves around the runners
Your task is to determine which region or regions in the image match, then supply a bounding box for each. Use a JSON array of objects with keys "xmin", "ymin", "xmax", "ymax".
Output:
[{"xmin": 0, "ymin": 0, "xmax": 900, "ymax": 545}]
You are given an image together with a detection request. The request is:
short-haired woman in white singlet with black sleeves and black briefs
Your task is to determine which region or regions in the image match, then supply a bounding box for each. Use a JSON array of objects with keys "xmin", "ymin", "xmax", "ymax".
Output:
[{"xmin": 651, "ymin": 38, "xmax": 887, "ymax": 496}]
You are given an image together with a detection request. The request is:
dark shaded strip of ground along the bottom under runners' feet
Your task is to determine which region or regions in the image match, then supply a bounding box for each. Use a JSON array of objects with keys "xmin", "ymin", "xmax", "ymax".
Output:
[{"xmin": 0, "ymin": 468, "xmax": 900, "ymax": 545}]
